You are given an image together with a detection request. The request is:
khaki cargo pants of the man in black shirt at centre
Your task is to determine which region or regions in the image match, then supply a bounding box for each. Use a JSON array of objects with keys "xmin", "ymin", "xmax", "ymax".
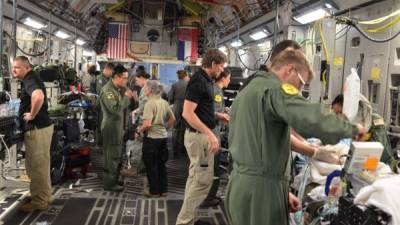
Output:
[{"xmin": 176, "ymin": 130, "xmax": 214, "ymax": 225}]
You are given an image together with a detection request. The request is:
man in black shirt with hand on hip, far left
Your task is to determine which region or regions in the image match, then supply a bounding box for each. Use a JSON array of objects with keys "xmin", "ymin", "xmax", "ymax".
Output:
[{"xmin": 12, "ymin": 56, "xmax": 54, "ymax": 212}]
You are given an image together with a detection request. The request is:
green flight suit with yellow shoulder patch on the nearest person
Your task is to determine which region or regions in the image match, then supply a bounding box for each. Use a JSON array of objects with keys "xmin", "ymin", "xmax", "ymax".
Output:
[{"xmin": 226, "ymin": 71, "xmax": 357, "ymax": 225}]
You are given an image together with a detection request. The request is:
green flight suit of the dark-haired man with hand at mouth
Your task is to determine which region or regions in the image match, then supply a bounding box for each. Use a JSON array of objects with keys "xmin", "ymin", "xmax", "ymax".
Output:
[{"xmin": 100, "ymin": 80, "xmax": 129, "ymax": 189}]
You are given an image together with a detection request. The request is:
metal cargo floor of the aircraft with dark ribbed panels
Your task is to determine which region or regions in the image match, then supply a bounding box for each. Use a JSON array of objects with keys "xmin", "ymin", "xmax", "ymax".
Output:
[{"xmin": 0, "ymin": 152, "xmax": 227, "ymax": 225}]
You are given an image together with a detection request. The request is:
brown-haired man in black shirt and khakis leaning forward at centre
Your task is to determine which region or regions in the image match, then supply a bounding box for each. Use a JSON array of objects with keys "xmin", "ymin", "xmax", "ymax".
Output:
[{"xmin": 176, "ymin": 49, "xmax": 229, "ymax": 225}]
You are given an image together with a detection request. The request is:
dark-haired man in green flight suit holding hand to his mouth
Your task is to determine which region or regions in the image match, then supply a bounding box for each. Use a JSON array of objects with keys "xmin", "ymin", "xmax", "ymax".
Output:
[{"xmin": 100, "ymin": 64, "xmax": 133, "ymax": 191}]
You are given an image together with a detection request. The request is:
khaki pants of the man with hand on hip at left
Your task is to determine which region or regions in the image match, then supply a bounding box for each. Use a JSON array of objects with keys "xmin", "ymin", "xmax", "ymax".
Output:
[{"xmin": 24, "ymin": 125, "xmax": 54, "ymax": 206}]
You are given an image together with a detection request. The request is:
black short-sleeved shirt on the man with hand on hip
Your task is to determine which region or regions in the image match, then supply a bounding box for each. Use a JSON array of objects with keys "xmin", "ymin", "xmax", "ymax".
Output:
[{"xmin": 19, "ymin": 71, "xmax": 52, "ymax": 131}]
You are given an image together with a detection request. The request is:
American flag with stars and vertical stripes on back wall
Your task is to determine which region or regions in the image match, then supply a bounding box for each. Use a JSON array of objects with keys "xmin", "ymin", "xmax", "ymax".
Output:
[{"xmin": 107, "ymin": 23, "xmax": 128, "ymax": 59}]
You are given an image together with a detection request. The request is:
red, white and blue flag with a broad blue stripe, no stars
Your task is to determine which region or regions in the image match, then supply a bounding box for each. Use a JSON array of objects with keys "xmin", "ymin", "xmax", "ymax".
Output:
[{"xmin": 177, "ymin": 28, "xmax": 199, "ymax": 62}]
